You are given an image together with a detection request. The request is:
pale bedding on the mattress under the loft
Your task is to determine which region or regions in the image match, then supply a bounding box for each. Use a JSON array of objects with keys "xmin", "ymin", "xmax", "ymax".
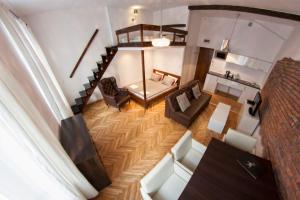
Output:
[{"xmin": 127, "ymin": 79, "xmax": 177, "ymax": 100}]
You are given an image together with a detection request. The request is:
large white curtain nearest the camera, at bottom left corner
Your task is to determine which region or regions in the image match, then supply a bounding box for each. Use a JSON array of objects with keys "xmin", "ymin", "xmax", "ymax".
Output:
[{"xmin": 0, "ymin": 61, "xmax": 97, "ymax": 200}]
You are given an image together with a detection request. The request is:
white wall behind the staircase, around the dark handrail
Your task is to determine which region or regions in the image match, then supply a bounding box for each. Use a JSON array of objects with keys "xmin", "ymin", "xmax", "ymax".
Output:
[{"xmin": 25, "ymin": 7, "xmax": 112, "ymax": 104}]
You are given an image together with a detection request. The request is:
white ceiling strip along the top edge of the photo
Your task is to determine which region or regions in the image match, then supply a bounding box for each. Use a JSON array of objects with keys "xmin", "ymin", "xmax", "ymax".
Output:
[{"xmin": 0, "ymin": 0, "xmax": 300, "ymax": 16}]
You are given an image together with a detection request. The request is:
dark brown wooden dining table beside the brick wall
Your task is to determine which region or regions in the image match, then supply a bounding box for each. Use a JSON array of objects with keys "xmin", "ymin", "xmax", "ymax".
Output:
[{"xmin": 179, "ymin": 139, "xmax": 279, "ymax": 200}]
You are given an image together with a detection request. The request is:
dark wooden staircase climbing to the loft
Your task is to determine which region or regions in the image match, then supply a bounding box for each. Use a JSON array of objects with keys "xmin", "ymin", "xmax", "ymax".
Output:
[{"xmin": 71, "ymin": 46, "xmax": 118, "ymax": 114}]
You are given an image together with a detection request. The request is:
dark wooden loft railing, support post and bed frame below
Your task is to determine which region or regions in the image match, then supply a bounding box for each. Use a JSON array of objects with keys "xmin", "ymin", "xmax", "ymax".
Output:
[{"xmin": 116, "ymin": 24, "xmax": 188, "ymax": 109}]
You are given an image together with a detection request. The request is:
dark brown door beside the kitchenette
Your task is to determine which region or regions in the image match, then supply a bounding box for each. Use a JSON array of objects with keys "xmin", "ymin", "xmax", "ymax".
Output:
[{"xmin": 194, "ymin": 47, "xmax": 214, "ymax": 86}]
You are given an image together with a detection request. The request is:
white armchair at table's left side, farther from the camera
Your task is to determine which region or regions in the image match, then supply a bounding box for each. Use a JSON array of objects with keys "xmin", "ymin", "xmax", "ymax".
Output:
[{"xmin": 171, "ymin": 130, "xmax": 206, "ymax": 175}]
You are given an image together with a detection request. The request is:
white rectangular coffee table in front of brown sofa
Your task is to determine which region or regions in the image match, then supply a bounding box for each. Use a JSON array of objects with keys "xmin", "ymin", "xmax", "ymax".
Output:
[{"xmin": 207, "ymin": 103, "xmax": 231, "ymax": 133}]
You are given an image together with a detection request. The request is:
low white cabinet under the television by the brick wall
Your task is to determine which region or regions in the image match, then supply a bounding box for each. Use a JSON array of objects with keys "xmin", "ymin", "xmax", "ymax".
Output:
[{"xmin": 237, "ymin": 102, "xmax": 260, "ymax": 135}]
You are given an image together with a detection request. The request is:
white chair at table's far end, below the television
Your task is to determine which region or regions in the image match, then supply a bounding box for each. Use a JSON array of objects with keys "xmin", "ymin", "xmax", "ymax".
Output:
[{"xmin": 223, "ymin": 128, "xmax": 257, "ymax": 154}]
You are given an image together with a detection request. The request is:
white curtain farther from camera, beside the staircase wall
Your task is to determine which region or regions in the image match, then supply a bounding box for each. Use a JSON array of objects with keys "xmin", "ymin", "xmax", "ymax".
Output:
[{"xmin": 0, "ymin": 2, "xmax": 72, "ymax": 123}]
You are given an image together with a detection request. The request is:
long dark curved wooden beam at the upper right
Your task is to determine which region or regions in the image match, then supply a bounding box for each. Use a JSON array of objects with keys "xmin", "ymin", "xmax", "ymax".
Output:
[{"xmin": 189, "ymin": 5, "xmax": 300, "ymax": 22}]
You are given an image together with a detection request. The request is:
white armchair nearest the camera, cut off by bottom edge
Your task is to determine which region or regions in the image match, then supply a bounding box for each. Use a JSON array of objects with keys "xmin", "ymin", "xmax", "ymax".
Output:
[{"xmin": 140, "ymin": 153, "xmax": 191, "ymax": 200}]
